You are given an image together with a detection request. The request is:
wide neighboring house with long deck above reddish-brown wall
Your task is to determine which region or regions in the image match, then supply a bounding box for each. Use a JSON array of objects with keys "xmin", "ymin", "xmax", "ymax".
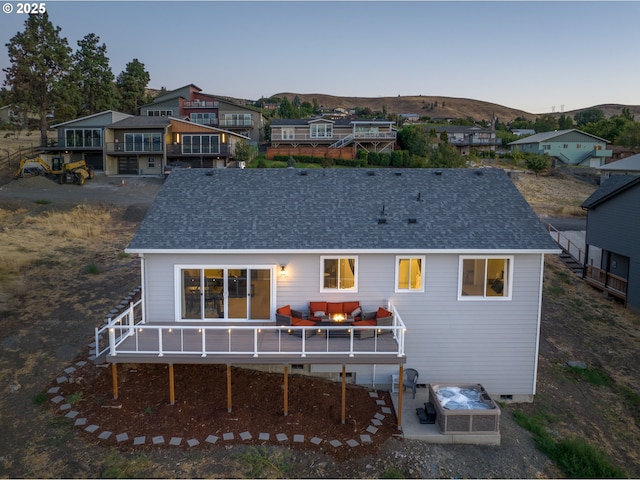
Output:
[{"xmin": 267, "ymin": 117, "xmax": 396, "ymax": 159}]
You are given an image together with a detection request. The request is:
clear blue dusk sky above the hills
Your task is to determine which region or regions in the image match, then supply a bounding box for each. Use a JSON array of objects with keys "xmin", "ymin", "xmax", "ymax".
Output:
[{"xmin": 0, "ymin": 0, "xmax": 640, "ymax": 113}]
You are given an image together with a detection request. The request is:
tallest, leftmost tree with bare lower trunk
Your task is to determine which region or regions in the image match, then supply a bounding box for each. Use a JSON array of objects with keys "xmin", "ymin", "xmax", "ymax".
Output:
[{"xmin": 3, "ymin": 12, "xmax": 71, "ymax": 145}]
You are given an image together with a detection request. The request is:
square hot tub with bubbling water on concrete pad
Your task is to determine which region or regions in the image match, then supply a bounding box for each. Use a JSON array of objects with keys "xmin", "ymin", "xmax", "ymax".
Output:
[{"xmin": 429, "ymin": 384, "xmax": 500, "ymax": 434}]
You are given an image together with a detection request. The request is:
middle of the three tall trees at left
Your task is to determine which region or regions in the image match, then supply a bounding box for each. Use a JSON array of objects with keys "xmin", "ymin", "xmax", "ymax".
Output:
[{"xmin": 73, "ymin": 33, "xmax": 116, "ymax": 115}]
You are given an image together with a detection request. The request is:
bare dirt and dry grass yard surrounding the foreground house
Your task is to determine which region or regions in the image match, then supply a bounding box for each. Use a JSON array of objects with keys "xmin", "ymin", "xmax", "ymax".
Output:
[{"xmin": 0, "ymin": 164, "xmax": 640, "ymax": 478}]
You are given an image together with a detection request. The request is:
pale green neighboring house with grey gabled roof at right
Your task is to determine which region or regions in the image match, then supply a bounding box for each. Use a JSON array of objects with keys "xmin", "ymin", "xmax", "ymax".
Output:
[{"xmin": 509, "ymin": 128, "xmax": 612, "ymax": 167}]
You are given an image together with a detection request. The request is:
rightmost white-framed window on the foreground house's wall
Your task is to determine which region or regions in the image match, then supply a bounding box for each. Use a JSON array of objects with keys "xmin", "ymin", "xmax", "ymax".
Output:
[{"xmin": 458, "ymin": 255, "xmax": 513, "ymax": 300}]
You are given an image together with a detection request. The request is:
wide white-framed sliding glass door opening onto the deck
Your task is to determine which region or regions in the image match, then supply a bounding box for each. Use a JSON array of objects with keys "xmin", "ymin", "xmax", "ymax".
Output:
[{"xmin": 177, "ymin": 267, "xmax": 274, "ymax": 321}]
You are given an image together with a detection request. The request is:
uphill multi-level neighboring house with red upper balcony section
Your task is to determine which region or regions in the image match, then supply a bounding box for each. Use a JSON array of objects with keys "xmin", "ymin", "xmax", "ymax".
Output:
[{"xmin": 140, "ymin": 84, "xmax": 264, "ymax": 145}]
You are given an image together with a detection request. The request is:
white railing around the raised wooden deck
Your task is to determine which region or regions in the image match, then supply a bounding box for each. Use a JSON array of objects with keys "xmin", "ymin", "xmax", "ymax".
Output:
[{"xmin": 96, "ymin": 302, "xmax": 406, "ymax": 358}]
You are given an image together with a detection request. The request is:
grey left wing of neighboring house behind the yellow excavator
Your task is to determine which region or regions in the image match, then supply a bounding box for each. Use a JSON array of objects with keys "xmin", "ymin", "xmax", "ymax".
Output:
[{"xmin": 47, "ymin": 110, "xmax": 133, "ymax": 170}]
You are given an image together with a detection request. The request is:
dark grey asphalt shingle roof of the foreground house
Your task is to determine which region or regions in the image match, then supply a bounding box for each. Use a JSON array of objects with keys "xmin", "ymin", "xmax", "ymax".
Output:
[{"xmin": 129, "ymin": 168, "xmax": 557, "ymax": 252}]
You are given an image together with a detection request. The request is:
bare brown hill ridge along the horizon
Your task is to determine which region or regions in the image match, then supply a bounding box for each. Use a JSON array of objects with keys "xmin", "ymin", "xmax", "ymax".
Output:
[{"xmin": 148, "ymin": 89, "xmax": 640, "ymax": 123}]
